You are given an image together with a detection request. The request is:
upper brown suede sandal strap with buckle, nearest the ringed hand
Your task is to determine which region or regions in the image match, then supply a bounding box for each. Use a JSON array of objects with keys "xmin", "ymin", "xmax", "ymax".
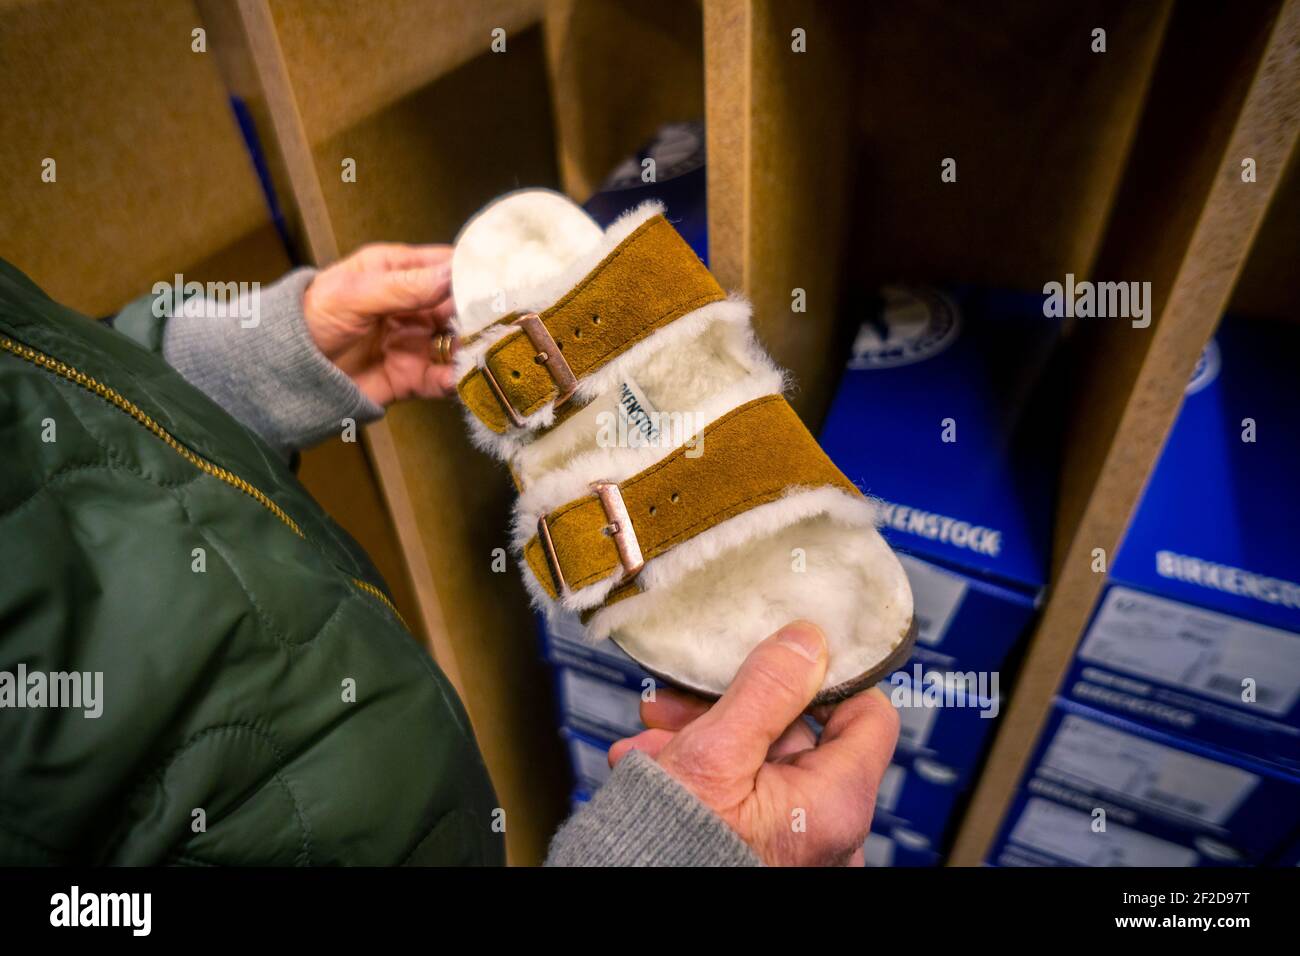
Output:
[{"xmin": 456, "ymin": 216, "xmax": 725, "ymax": 433}]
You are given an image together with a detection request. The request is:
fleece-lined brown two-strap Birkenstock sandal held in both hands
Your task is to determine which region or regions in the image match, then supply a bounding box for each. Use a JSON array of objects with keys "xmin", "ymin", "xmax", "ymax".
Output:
[{"xmin": 451, "ymin": 190, "xmax": 915, "ymax": 702}]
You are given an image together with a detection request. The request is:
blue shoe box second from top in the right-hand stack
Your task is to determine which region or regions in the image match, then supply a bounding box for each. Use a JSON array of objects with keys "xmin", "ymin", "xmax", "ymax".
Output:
[{"xmin": 998, "ymin": 700, "xmax": 1300, "ymax": 864}]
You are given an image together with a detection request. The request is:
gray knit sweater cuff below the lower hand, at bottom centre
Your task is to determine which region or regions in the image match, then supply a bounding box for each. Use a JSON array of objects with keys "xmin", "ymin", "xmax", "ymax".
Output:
[{"xmin": 546, "ymin": 750, "xmax": 762, "ymax": 866}]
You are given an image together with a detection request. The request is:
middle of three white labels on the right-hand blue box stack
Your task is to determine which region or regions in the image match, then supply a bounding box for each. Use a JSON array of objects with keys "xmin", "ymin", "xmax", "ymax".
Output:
[{"xmin": 1041, "ymin": 714, "xmax": 1260, "ymax": 823}]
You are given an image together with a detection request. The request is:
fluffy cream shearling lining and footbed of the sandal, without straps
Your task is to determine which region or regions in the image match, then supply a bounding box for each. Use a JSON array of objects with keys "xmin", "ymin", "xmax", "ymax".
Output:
[{"xmin": 452, "ymin": 190, "xmax": 913, "ymax": 695}]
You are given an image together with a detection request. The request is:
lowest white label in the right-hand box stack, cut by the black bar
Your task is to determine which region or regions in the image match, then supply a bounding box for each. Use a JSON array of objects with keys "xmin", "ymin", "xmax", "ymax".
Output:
[{"xmin": 1010, "ymin": 797, "xmax": 1196, "ymax": 866}]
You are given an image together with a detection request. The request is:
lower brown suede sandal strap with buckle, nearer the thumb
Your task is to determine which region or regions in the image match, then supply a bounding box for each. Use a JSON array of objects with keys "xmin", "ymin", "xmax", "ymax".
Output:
[{"xmin": 524, "ymin": 395, "xmax": 861, "ymax": 602}]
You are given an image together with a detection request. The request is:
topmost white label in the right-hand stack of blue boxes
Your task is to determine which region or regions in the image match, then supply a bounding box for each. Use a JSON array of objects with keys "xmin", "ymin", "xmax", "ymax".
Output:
[{"xmin": 1079, "ymin": 588, "xmax": 1300, "ymax": 717}]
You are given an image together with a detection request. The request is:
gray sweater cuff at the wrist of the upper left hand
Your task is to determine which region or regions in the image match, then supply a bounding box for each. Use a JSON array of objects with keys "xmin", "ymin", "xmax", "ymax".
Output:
[{"xmin": 163, "ymin": 269, "xmax": 384, "ymax": 458}]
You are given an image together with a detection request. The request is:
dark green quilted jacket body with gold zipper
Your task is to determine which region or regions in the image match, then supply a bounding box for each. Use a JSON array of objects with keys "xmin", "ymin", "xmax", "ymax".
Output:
[{"xmin": 0, "ymin": 261, "xmax": 503, "ymax": 865}]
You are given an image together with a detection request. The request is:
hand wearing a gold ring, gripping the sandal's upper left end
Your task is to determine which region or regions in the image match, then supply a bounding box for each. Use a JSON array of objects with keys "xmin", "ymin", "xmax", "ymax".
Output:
[{"xmin": 303, "ymin": 243, "xmax": 456, "ymax": 405}]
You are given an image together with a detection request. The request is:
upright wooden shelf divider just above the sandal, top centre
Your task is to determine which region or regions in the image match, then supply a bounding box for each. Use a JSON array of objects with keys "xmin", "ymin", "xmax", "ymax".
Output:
[{"xmin": 703, "ymin": 0, "xmax": 854, "ymax": 423}]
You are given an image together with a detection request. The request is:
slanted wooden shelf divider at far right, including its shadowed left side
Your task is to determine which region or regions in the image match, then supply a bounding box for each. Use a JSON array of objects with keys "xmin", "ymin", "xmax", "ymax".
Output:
[{"xmin": 950, "ymin": 0, "xmax": 1300, "ymax": 865}]
